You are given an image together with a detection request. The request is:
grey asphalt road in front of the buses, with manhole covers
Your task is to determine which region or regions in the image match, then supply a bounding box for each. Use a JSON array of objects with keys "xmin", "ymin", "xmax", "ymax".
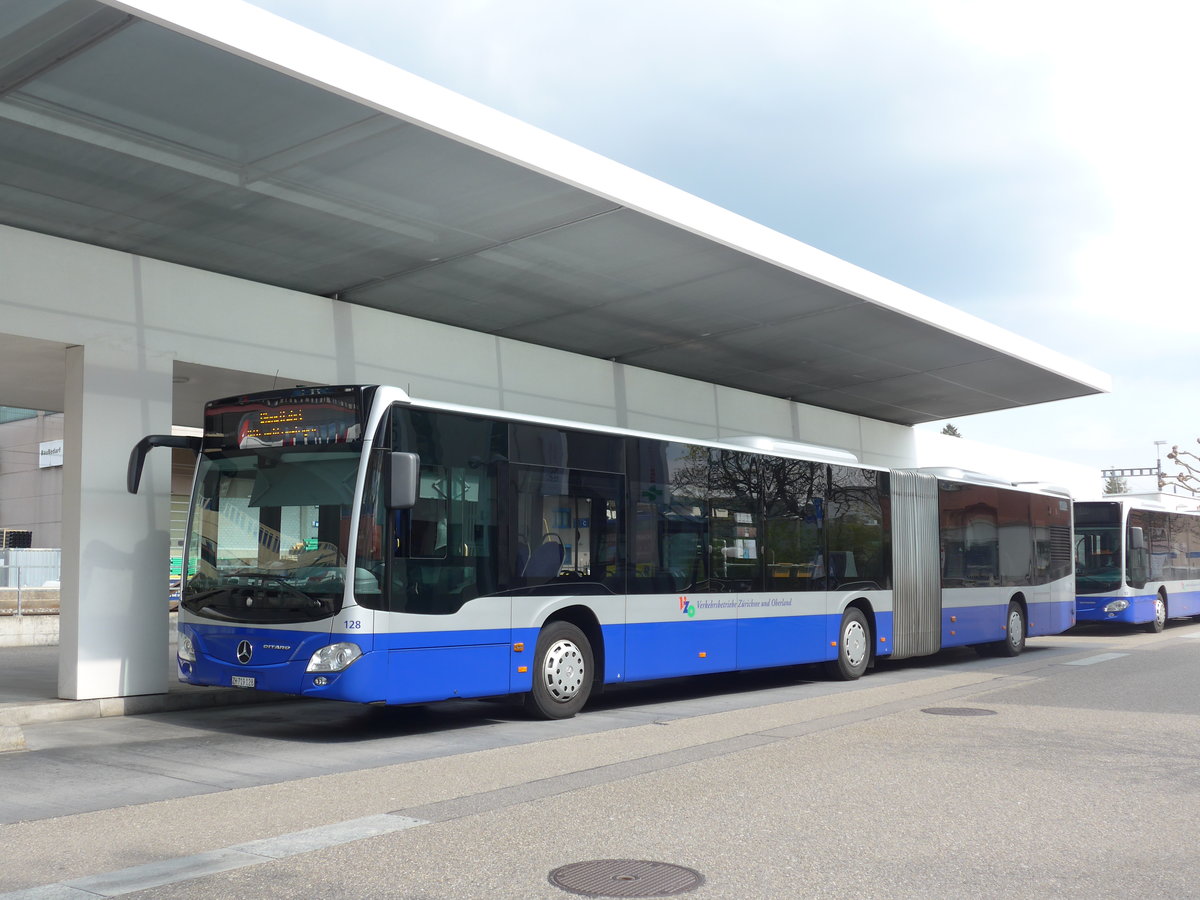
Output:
[{"xmin": 0, "ymin": 620, "xmax": 1200, "ymax": 900}]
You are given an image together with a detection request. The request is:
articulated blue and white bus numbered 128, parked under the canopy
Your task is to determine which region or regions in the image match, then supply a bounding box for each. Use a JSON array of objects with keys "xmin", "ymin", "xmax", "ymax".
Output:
[{"xmin": 130, "ymin": 386, "xmax": 1075, "ymax": 718}]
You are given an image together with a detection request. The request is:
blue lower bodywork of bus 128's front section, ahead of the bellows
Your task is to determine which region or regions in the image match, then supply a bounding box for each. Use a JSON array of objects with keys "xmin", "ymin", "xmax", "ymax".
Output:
[{"xmin": 179, "ymin": 602, "xmax": 907, "ymax": 704}]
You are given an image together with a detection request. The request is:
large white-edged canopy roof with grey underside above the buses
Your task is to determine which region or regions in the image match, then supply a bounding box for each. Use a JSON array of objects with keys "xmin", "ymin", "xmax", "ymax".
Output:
[{"xmin": 0, "ymin": 0, "xmax": 1109, "ymax": 425}]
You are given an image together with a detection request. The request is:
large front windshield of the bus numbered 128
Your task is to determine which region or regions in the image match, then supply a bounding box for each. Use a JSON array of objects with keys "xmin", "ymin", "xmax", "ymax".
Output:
[{"xmin": 181, "ymin": 449, "xmax": 360, "ymax": 623}]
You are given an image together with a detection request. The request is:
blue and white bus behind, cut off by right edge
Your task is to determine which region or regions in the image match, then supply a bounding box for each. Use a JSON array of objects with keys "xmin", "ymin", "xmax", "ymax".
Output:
[{"xmin": 1075, "ymin": 498, "xmax": 1200, "ymax": 632}]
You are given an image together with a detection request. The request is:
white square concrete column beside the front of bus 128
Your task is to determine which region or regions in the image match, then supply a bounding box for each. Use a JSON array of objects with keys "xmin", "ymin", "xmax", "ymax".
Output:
[{"xmin": 59, "ymin": 341, "xmax": 172, "ymax": 700}]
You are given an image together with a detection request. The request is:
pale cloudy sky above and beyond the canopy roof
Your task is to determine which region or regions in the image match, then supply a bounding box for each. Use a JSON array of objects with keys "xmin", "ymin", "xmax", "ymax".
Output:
[{"xmin": 246, "ymin": 0, "xmax": 1200, "ymax": 490}]
